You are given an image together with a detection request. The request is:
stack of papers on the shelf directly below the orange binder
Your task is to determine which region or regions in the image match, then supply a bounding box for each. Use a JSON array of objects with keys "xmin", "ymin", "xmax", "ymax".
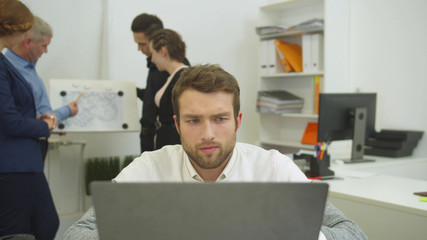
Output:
[{"xmin": 257, "ymin": 90, "xmax": 304, "ymax": 114}]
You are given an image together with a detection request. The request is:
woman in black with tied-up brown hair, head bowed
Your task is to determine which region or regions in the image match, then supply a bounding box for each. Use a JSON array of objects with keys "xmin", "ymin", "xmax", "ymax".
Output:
[{"xmin": 149, "ymin": 29, "xmax": 187, "ymax": 149}]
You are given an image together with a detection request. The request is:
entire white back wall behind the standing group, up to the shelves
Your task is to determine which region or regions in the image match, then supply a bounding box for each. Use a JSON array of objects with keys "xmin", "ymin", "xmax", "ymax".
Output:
[{"xmin": 23, "ymin": 0, "xmax": 264, "ymax": 158}]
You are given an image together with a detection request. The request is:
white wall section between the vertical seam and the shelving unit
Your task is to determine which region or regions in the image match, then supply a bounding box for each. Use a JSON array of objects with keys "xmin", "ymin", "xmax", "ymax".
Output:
[{"xmin": 108, "ymin": 0, "xmax": 260, "ymax": 143}]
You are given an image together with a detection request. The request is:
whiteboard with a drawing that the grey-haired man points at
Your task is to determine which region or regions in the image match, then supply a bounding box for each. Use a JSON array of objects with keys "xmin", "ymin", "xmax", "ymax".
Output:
[{"xmin": 49, "ymin": 79, "xmax": 140, "ymax": 132}]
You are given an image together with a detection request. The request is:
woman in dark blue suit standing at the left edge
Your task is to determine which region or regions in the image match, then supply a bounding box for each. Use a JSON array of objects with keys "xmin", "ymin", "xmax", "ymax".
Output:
[{"xmin": 0, "ymin": 0, "xmax": 59, "ymax": 240}]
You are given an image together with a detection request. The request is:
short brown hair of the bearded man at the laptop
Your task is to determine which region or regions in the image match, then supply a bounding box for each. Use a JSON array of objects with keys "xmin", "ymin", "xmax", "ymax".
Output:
[{"xmin": 172, "ymin": 64, "xmax": 240, "ymax": 124}]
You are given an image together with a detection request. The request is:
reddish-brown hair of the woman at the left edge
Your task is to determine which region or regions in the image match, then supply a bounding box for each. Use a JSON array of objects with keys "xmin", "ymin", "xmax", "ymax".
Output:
[{"xmin": 0, "ymin": 0, "xmax": 34, "ymax": 36}]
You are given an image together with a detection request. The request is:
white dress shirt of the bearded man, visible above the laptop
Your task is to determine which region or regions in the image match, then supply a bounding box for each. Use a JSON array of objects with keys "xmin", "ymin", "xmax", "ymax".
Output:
[{"xmin": 114, "ymin": 143, "xmax": 309, "ymax": 182}]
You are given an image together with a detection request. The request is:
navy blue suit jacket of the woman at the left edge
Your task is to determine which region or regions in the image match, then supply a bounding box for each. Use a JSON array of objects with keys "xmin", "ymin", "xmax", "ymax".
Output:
[{"xmin": 0, "ymin": 53, "xmax": 49, "ymax": 172}]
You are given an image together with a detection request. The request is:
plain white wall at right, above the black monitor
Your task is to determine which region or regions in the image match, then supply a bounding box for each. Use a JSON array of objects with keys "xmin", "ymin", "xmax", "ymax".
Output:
[{"xmin": 325, "ymin": 0, "xmax": 427, "ymax": 156}]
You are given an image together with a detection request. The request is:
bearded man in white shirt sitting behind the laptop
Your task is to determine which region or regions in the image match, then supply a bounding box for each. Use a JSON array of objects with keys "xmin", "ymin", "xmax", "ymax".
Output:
[{"xmin": 63, "ymin": 65, "xmax": 367, "ymax": 240}]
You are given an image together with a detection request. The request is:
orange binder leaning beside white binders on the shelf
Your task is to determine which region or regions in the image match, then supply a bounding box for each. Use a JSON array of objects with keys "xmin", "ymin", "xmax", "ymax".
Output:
[{"xmin": 274, "ymin": 39, "xmax": 302, "ymax": 72}]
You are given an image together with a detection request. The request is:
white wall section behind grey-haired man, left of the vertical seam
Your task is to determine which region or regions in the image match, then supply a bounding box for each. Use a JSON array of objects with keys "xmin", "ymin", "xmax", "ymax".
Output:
[{"xmin": 22, "ymin": 0, "xmax": 103, "ymax": 79}]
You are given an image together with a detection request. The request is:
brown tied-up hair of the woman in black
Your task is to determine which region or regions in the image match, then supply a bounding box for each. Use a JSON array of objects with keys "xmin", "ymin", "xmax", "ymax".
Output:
[{"xmin": 149, "ymin": 29, "xmax": 185, "ymax": 62}]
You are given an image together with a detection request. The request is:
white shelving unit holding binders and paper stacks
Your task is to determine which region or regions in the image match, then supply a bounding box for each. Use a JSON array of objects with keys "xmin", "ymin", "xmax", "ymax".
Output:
[{"xmin": 258, "ymin": 0, "xmax": 326, "ymax": 153}]
